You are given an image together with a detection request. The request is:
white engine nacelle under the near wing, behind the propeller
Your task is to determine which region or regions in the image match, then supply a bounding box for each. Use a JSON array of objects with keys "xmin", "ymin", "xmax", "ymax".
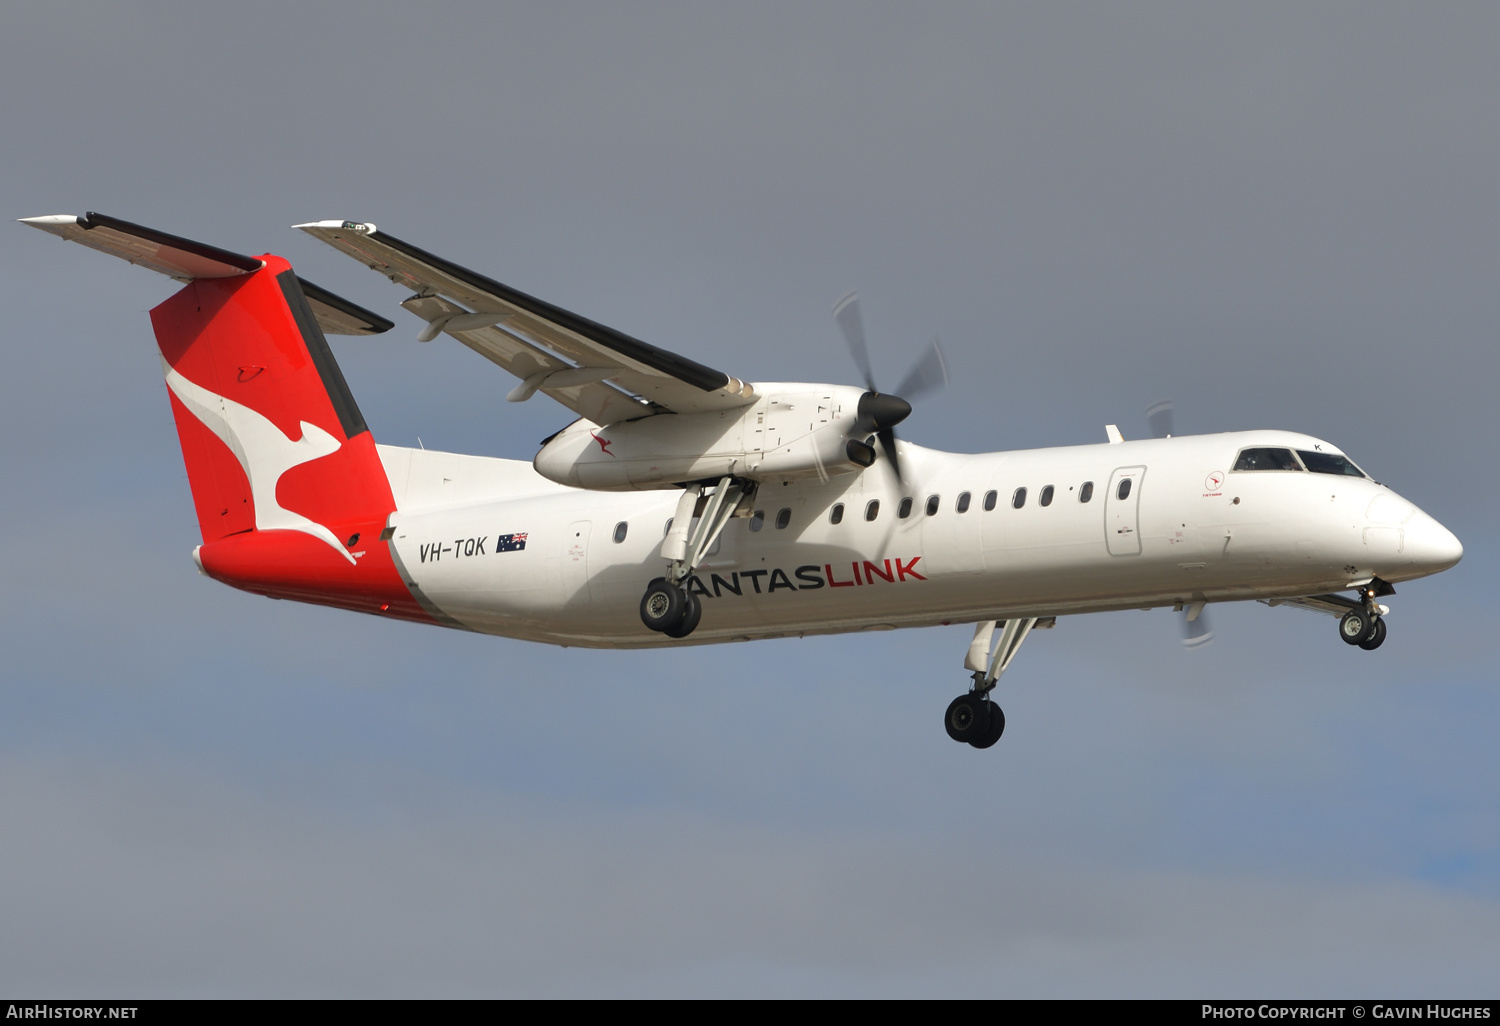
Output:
[{"xmin": 533, "ymin": 383, "xmax": 873, "ymax": 492}]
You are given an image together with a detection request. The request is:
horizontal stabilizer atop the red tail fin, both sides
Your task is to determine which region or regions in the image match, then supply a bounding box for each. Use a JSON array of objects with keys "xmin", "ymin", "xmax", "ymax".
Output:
[{"xmin": 21, "ymin": 210, "xmax": 396, "ymax": 335}]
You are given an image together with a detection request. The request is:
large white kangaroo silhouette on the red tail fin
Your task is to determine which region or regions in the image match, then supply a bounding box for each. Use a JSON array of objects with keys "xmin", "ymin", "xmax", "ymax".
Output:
[{"xmin": 162, "ymin": 359, "xmax": 356, "ymax": 563}]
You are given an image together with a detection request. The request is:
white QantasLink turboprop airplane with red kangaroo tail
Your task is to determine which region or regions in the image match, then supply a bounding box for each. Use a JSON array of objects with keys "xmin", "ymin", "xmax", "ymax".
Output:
[{"xmin": 23, "ymin": 212, "xmax": 1463, "ymax": 749}]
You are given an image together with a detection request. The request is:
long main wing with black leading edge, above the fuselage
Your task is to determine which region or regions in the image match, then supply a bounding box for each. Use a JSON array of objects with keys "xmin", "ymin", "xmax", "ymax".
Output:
[{"xmin": 297, "ymin": 221, "xmax": 756, "ymax": 425}]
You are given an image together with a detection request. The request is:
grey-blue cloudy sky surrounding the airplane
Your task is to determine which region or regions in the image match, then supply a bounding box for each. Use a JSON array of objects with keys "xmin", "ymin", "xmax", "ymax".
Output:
[{"xmin": 0, "ymin": 3, "xmax": 1500, "ymax": 996}]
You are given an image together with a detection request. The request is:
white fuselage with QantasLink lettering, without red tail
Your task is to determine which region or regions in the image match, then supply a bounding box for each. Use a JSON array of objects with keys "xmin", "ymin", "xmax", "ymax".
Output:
[{"xmin": 381, "ymin": 431, "xmax": 1463, "ymax": 647}]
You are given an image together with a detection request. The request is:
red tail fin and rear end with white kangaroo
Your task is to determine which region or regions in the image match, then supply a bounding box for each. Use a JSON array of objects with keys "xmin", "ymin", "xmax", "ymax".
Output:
[{"xmin": 152, "ymin": 255, "xmax": 429, "ymax": 620}]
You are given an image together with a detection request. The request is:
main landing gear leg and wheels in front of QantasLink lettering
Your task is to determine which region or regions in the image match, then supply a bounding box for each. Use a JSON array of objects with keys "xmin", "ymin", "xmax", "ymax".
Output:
[{"xmin": 641, "ymin": 477, "xmax": 755, "ymax": 638}]
